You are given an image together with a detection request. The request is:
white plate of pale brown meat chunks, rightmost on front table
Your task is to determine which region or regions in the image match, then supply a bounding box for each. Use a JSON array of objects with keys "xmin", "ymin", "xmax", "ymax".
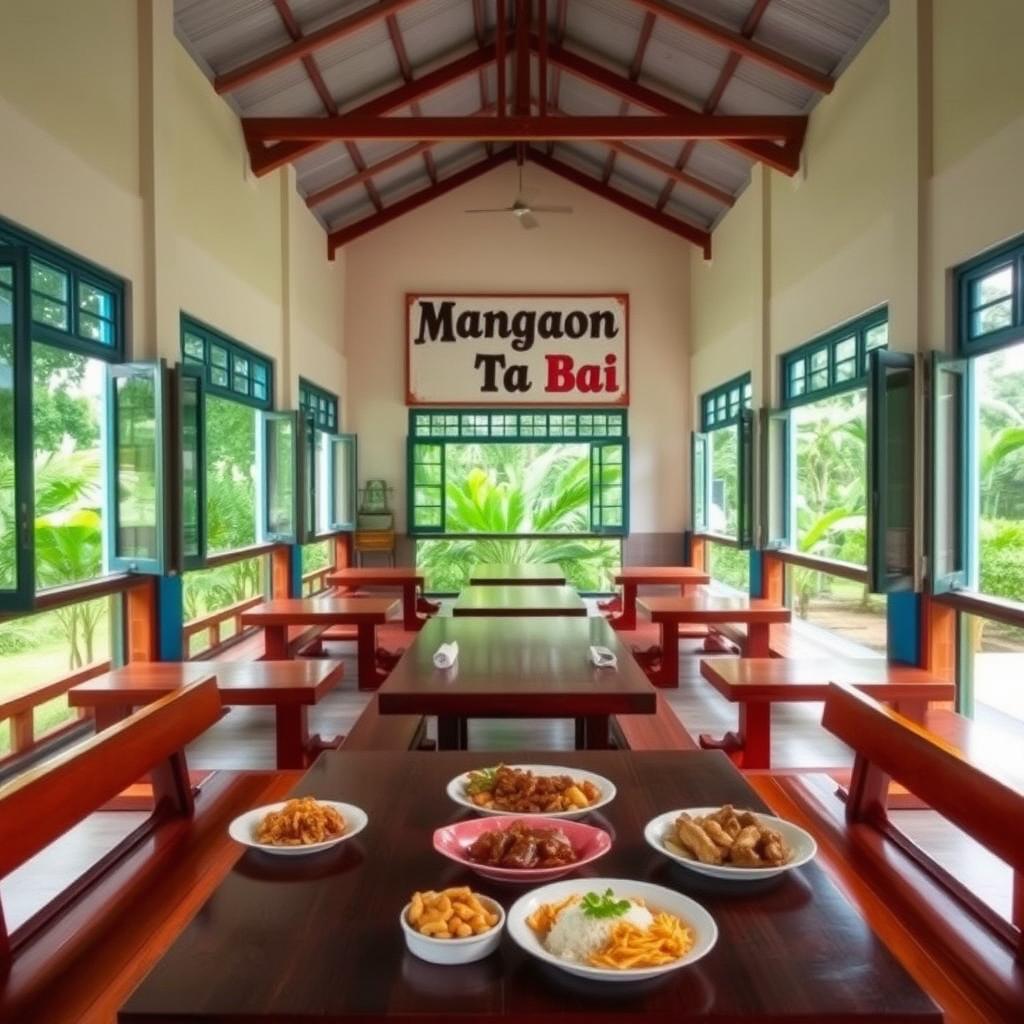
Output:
[{"xmin": 644, "ymin": 804, "xmax": 818, "ymax": 882}]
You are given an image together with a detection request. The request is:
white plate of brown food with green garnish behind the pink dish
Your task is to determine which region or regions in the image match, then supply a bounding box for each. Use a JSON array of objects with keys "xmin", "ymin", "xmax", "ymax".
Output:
[{"xmin": 447, "ymin": 765, "xmax": 615, "ymax": 818}]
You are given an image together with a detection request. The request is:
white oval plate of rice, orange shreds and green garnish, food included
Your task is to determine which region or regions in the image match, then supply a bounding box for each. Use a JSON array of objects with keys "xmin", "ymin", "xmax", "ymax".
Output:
[{"xmin": 508, "ymin": 879, "xmax": 718, "ymax": 982}]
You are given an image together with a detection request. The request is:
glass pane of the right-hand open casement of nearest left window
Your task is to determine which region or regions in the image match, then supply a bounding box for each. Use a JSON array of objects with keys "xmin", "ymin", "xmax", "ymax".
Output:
[{"xmin": 115, "ymin": 374, "xmax": 161, "ymax": 559}]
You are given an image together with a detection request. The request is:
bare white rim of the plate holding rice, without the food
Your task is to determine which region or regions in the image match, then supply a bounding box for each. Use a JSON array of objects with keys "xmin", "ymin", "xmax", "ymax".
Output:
[{"xmin": 507, "ymin": 879, "xmax": 718, "ymax": 982}]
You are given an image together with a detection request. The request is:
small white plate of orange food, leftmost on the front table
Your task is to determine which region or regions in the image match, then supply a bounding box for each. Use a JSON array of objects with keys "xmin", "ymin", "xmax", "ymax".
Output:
[{"xmin": 227, "ymin": 797, "xmax": 369, "ymax": 857}]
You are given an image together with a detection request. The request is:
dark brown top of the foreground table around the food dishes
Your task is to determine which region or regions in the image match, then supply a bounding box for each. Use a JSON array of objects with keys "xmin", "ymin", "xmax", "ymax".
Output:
[{"xmin": 118, "ymin": 751, "xmax": 942, "ymax": 1024}]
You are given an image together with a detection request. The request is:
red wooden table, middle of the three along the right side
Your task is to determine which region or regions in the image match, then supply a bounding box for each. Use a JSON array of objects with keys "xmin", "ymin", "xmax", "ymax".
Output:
[{"xmin": 637, "ymin": 592, "xmax": 793, "ymax": 686}]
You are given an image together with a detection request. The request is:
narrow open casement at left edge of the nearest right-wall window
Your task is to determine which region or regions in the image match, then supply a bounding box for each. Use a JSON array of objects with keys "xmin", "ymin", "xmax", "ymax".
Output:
[{"xmin": 928, "ymin": 352, "xmax": 971, "ymax": 594}]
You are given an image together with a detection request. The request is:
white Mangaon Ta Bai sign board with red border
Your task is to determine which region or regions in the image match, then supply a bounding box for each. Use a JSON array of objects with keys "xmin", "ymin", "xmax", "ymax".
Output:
[{"xmin": 406, "ymin": 295, "xmax": 629, "ymax": 406}]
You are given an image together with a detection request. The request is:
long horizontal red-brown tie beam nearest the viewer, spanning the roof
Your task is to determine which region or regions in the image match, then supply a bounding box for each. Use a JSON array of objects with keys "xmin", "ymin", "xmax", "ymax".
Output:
[{"xmin": 242, "ymin": 111, "xmax": 807, "ymax": 142}]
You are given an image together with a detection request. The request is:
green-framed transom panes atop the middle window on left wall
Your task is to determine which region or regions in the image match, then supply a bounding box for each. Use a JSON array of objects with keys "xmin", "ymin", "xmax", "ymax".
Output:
[{"xmin": 180, "ymin": 313, "xmax": 273, "ymax": 411}]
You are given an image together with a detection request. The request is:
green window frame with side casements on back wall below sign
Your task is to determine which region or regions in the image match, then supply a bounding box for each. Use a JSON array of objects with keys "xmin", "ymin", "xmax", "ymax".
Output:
[{"xmin": 406, "ymin": 409, "xmax": 630, "ymax": 537}]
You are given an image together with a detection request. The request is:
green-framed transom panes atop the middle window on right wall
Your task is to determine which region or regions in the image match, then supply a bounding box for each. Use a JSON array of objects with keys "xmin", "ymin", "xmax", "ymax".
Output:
[{"xmin": 781, "ymin": 306, "xmax": 889, "ymax": 409}]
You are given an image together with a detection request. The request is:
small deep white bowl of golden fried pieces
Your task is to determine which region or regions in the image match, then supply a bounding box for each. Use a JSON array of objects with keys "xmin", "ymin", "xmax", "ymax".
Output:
[{"xmin": 399, "ymin": 886, "xmax": 505, "ymax": 966}]
